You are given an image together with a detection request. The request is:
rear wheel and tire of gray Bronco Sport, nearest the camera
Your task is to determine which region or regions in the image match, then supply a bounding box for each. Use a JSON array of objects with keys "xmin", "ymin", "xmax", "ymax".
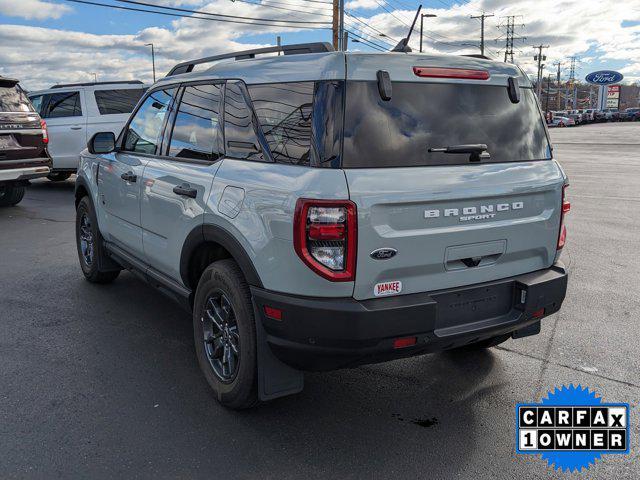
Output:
[{"xmin": 193, "ymin": 259, "xmax": 259, "ymax": 410}]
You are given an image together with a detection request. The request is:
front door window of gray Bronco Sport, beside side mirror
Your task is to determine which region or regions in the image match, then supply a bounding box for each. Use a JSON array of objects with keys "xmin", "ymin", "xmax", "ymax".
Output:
[{"xmin": 123, "ymin": 88, "xmax": 175, "ymax": 155}]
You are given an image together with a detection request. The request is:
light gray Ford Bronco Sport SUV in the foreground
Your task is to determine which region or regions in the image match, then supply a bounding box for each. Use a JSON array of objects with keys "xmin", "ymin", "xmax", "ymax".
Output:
[{"xmin": 76, "ymin": 44, "xmax": 569, "ymax": 408}]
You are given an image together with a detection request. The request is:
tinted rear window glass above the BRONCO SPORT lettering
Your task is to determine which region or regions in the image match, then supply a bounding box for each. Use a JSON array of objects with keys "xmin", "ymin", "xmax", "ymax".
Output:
[{"xmin": 342, "ymin": 82, "xmax": 551, "ymax": 168}]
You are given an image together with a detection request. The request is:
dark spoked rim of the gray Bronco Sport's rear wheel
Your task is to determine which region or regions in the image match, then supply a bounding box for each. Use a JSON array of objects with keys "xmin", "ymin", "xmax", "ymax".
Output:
[{"xmin": 202, "ymin": 290, "xmax": 240, "ymax": 382}]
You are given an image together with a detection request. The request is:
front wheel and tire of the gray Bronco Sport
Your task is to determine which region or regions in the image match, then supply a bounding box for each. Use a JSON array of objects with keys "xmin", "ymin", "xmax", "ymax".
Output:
[{"xmin": 76, "ymin": 197, "xmax": 120, "ymax": 283}]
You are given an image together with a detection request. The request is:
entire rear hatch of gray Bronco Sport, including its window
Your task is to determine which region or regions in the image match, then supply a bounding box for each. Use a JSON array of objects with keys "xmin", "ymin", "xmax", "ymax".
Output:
[{"xmin": 342, "ymin": 55, "xmax": 564, "ymax": 299}]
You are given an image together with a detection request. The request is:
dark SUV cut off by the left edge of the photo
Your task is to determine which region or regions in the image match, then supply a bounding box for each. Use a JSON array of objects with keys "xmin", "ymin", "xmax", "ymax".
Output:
[{"xmin": 0, "ymin": 77, "xmax": 51, "ymax": 207}]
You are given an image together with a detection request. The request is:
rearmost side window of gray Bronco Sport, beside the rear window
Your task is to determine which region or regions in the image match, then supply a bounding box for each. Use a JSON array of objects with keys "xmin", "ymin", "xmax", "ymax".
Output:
[{"xmin": 247, "ymin": 82, "xmax": 314, "ymax": 165}]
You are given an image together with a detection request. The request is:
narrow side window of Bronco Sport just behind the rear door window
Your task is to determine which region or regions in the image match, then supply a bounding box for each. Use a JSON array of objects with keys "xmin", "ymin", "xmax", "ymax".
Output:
[{"xmin": 224, "ymin": 81, "xmax": 264, "ymax": 160}]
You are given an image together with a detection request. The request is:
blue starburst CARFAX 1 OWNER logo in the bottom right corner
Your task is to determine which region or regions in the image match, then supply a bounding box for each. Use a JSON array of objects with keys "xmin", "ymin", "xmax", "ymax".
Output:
[{"xmin": 516, "ymin": 385, "xmax": 629, "ymax": 472}]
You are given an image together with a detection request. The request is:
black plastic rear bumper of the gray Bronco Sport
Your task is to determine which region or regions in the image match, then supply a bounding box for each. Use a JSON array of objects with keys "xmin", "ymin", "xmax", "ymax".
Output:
[{"xmin": 251, "ymin": 263, "xmax": 567, "ymax": 370}]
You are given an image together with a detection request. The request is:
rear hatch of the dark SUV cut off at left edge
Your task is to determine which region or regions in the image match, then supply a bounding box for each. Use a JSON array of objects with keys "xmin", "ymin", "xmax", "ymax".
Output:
[{"xmin": 0, "ymin": 78, "xmax": 48, "ymax": 168}]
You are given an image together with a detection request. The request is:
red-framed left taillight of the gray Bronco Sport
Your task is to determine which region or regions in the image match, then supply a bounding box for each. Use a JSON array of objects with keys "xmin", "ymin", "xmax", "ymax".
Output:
[{"xmin": 293, "ymin": 198, "xmax": 358, "ymax": 282}]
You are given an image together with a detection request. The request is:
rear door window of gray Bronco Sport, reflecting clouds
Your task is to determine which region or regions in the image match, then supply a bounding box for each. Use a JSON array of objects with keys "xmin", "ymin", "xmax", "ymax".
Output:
[{"xmin": 169, "ymin": 84, "xmax": 222, "ymax": 160}]
